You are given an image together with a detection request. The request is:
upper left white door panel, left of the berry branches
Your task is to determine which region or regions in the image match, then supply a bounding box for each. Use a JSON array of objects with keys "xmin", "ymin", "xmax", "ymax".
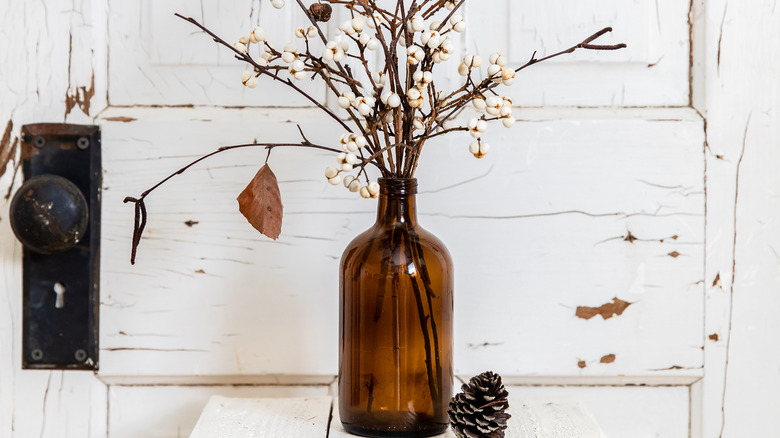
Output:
[{"xmin": 108, "ymin": 0, "xmax": 325, "ymax": 107}]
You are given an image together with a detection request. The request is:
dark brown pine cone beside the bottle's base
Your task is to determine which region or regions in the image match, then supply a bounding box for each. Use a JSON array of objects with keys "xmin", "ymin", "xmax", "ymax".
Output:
[{"xmin": 449, "ymin": 371, "xmax": 511, "ymax": 438}]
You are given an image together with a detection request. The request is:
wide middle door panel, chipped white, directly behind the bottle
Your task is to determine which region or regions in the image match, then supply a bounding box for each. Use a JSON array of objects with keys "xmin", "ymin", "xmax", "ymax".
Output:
[{"xmin": 101, "ymin": 109, "xmax": 704, "ymax": 376}]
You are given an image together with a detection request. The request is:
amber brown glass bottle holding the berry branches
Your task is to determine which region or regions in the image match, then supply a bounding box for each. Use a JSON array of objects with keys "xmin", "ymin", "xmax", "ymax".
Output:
[{"xmin": 339, "ymin": 179, "xmax": 453, "ymax": 437}]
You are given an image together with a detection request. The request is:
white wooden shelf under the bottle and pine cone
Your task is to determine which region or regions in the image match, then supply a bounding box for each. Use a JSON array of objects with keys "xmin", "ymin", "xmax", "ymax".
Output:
[{"xmin": 190, "ymin": 396, "xmax": 605, "ymax": 438}]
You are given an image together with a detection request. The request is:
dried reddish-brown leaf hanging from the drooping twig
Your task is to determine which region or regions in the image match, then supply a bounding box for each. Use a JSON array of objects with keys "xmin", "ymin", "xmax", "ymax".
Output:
[{"xmin": 237, "ymin": 164, "xmax": 283, "ymax": 240}]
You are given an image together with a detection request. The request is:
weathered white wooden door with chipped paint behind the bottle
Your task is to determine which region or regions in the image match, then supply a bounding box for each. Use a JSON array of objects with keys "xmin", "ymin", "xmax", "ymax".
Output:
[{"xmin": 0, "ymin": 0, "xmax": 780, "ymax": 438}]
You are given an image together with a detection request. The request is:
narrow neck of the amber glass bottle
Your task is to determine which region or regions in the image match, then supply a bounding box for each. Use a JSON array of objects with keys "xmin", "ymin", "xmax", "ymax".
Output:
[{"xmin": 376, "ymin": 178, "xmax": 417, "ymax": 227}]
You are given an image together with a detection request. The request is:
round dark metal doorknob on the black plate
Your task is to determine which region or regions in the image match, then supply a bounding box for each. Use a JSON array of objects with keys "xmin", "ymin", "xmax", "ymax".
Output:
[{"xmin": 10, "ymin": 175, "xmax": 88, "ymax": 254}]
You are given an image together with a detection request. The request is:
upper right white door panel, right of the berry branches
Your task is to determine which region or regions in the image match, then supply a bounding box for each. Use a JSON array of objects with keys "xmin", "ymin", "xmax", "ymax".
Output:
[{"xmin": 465, "ymin": 0, "xmax": 690, "ymax": 107}]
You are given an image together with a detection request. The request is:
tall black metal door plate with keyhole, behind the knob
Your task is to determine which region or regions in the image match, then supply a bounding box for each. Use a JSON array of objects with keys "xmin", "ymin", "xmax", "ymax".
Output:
[{"xmin": 22, "ymin": 123, "xmax": 102, "ymax": 370}]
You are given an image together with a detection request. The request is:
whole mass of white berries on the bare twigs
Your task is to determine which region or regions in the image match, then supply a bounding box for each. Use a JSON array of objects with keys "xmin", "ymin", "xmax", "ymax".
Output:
[{"xmin": 233, "ymin": 0, "xmax": 516, "ymax": 185}]
